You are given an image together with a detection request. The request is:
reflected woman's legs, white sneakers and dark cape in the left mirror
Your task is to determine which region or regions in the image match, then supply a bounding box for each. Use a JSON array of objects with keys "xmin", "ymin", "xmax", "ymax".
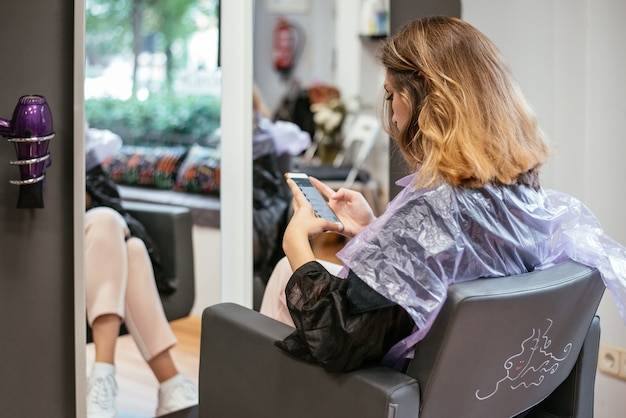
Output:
[{"xmin": 85, "ymin": 127, "xmax": 198, "ymax": 418}]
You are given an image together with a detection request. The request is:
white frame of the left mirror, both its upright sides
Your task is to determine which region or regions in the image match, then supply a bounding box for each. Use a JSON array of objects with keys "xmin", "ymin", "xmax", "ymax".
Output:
[{"xmin": 73, "ymin": 0, "xmax": 254, "ymax": 418}]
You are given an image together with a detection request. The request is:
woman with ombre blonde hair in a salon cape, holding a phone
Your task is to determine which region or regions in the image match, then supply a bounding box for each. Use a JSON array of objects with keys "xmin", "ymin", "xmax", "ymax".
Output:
[{"xmin": 261, "ymin": 17, "xmax": 626, "ymax": 371}]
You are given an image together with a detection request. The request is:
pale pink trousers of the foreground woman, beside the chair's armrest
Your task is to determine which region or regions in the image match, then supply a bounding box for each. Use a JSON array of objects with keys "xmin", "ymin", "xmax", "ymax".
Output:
[{"xmin": 259, "ymin": 257, "xmax": 342, "ymax": 327}]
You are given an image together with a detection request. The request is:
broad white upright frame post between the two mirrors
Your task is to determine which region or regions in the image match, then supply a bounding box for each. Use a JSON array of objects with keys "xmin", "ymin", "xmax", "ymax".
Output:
[{"xmin": 220, "ymin": 0, "xmax": 254, "ymax": 307}]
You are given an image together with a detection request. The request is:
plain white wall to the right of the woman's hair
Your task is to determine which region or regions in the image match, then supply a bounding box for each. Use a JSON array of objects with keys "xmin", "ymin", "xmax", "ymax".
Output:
[{"xmin": 462, "ymin": 0, "xmax": 626, "ymax": 418}]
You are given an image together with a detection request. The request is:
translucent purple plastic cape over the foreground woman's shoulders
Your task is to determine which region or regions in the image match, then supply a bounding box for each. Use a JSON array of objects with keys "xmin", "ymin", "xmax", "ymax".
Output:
[{"xmin": 337, "ymin": 174, "xmax": 626, "ymax": 366}]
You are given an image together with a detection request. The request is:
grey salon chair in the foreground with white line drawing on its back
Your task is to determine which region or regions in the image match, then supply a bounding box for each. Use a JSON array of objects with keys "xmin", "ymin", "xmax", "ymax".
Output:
[{"xmin": 194, "ymin": 261, "xmax": 604, "ymax": 418}]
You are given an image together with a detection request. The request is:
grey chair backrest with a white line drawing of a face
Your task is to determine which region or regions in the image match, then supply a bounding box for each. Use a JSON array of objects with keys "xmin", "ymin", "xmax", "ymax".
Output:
[{"xmin": 407, "ymin": 261, "xmax": 604, "ymax": 418}]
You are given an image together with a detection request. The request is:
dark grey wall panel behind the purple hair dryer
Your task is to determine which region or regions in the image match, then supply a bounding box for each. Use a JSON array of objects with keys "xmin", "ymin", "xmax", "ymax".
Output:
[{"xmin": 0, "ymin": 0, "xmax": 76, "ymax": 418}]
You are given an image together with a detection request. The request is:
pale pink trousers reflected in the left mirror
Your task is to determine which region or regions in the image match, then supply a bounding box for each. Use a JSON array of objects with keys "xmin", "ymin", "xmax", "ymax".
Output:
[{"xmin": 85, "ymin": 207, "xmax": 177, "ymax": 361}]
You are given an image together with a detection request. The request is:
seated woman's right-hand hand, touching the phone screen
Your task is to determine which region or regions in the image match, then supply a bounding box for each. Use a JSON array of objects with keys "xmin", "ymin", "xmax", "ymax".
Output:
[{"xmin": 309, "ymin": 177, "xmax": 376, "ymax": 238}]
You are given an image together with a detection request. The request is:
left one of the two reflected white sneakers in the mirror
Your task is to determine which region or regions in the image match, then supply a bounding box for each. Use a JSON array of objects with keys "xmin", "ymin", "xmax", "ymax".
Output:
[{"xmin": 87, "ymin": 363, "xmax": 117, "ymax": 418}]
